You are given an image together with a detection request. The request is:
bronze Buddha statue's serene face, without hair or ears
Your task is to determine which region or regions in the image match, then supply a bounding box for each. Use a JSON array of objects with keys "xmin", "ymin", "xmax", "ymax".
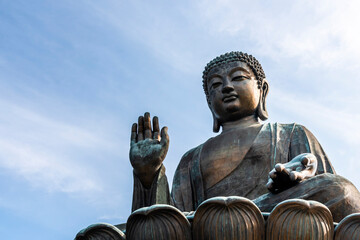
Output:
[{"xmin": 207, "ymin": 62, "xmax": 260, "ymax": 123}]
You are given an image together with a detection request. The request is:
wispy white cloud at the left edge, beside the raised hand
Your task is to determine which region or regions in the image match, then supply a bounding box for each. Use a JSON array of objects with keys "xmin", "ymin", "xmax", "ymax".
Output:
[{"xmin": 0, "ymin": 100, "xmax": 119, "ymax": 193}]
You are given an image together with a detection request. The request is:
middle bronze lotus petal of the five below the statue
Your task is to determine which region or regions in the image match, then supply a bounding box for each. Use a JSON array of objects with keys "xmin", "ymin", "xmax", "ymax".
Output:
[{"xmin": 192, "ymin": 197, "xmax": 265, "ymax": 240}]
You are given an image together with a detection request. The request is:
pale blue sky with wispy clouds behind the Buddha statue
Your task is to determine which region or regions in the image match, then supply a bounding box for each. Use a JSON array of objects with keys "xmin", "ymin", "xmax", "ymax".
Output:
[{"xmin": 0, "ymin": 0, "xmax": 360, "ymax": 239}]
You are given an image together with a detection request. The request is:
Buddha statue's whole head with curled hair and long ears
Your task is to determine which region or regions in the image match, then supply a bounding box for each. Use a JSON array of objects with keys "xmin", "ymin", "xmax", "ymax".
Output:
[{"xmin": 203, "ymin": 52, "xmax": 269, "ymax": 132}]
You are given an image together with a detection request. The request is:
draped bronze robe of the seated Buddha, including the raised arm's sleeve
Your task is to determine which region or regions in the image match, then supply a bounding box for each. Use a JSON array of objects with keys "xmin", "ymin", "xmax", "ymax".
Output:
[{"xmin": 133, "ymin": 123, "xmax": 360, "ymax": 219}]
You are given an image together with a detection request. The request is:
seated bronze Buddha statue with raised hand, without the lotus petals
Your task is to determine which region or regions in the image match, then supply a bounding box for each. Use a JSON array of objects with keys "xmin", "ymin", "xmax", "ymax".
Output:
[{"xmin": 130, "ymin": 52, "xmax": 360, "ymax": 221}]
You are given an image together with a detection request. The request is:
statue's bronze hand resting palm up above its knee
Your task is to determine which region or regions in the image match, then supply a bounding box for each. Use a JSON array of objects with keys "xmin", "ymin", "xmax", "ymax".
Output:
[{"xmin": 266, "ymin": 153, "xmax": 318, "ymax": 193}]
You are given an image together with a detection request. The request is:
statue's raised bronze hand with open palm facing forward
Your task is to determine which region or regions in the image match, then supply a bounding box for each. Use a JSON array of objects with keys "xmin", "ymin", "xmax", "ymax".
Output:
[{"xmin": 129, "ymin": 112, "xmax": 169, "ymax": 188}]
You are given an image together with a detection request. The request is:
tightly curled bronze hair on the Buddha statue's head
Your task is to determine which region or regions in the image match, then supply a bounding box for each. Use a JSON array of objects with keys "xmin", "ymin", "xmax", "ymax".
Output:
[{"xmin": 203, "ymin": 52, "xmax": 265, "ymax": 103}]
